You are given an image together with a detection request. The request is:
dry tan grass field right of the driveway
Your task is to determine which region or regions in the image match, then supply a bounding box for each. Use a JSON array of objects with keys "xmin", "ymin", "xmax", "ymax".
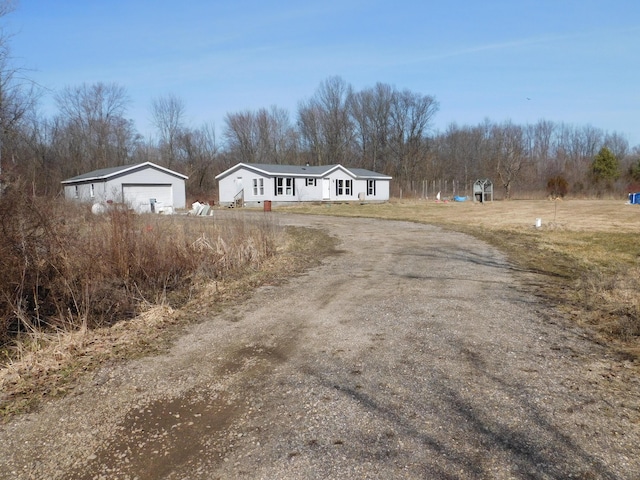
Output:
[{"xmin": 286, "ymin": 200, "xmax": 640, "ymax": 358}]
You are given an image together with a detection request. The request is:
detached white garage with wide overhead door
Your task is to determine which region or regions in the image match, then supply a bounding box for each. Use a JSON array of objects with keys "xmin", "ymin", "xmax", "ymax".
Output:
[{"xmin": 62, "ymin": 162, "xmax": 188, "ymax": 213}]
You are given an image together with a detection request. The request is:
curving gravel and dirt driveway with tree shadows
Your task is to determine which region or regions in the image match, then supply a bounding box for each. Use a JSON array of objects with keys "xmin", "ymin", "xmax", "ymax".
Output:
[{"xmin": 0, "ymin": 212, "xmax": 640, "ymax": 480}]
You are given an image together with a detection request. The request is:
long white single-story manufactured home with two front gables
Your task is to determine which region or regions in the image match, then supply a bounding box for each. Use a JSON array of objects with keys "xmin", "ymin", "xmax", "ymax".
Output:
[{"xmin": 216, "ymin": 163, "xmax": 391, "ymax": 206}]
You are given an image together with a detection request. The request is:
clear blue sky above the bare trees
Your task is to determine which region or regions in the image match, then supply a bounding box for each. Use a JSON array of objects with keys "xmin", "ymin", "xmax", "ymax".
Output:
[{"xmin": 5, "ymin": 0, "xmax": 640, "ymax": 146}]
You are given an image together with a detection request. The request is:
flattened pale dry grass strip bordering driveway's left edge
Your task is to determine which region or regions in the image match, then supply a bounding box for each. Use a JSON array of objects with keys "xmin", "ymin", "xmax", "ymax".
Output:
[{"xmin": 0, "ymin": 214, "xmax": 335, "ymax": 420}]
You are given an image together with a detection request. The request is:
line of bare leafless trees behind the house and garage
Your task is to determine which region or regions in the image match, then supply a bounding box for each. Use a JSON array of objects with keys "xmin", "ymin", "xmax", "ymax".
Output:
[{"xmin": 0, "ymin": 7, "xmax": 640, "ymax": 198}]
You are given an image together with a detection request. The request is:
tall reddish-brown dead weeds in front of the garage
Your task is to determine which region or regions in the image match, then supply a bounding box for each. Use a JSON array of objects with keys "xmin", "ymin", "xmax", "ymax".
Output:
[{"xmin": 0, "ymin": 184, "xmax": 279, "ymax": 347}]
